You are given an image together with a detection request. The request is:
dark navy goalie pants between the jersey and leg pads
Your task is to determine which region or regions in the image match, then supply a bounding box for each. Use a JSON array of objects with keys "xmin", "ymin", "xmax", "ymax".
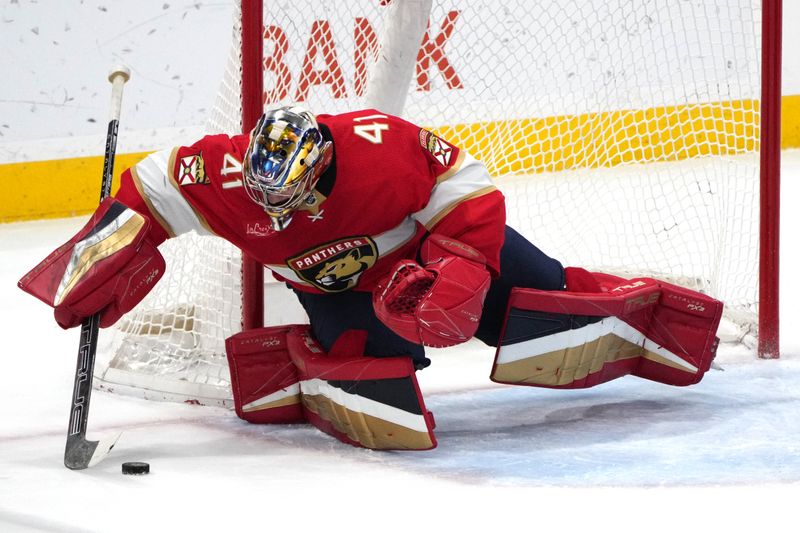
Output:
[{"xmin": 295, "ymin": 226, "xmax": 564, "ymax": 369}]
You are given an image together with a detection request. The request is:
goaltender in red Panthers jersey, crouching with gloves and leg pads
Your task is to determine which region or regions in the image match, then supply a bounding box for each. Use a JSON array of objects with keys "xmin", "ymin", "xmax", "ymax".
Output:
[{"xmin": 20, "ymin": 107, "xmax": 722, "ymax": 450}]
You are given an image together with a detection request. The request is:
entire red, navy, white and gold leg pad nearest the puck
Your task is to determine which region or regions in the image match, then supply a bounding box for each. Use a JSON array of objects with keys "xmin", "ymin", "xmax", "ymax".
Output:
[{"xmin": 225, "ymin": 325, "xmax": 436, "ymax": 450}]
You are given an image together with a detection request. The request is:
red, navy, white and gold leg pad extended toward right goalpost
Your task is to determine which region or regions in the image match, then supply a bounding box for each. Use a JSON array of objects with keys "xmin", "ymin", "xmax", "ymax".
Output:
[{"xmin": 491, "ymin": 278, "xmax": 722, "ymax": 388}]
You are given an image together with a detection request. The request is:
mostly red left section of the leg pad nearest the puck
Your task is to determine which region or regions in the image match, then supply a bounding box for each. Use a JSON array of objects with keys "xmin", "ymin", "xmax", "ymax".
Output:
[{"xmin": 225, "ymin": 326, "xmax": 306, "ymax": 424}]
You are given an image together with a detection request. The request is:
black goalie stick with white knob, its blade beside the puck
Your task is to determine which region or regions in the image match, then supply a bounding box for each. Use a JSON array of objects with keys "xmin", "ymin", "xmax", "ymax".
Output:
[{"xmin": 64, "ymin": 66, "xmax": 131, "ymax": 470}]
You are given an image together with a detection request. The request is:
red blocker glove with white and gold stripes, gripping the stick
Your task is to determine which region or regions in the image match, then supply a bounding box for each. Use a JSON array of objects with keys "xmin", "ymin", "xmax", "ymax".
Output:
[{"xmin": 18, "ymin": 198, "xmax": 164, "ymax": 329}]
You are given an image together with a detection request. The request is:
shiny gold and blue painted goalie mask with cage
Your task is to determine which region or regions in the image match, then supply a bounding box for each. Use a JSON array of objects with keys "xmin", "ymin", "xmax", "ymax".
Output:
[{"xmin": 243, "ymin": 107, "xmax": 333, "ymax": 231}]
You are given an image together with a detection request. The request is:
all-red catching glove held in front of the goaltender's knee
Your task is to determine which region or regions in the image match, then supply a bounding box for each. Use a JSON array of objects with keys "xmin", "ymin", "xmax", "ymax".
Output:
[{"xmin": 372, "ymin": 234, "xmax": 491, "ymax": 348}]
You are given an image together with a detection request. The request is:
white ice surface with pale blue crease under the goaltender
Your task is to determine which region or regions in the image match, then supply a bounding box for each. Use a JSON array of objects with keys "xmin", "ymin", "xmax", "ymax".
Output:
[{"xmin": 0, "ymin": 151, "xmax": 800, "ymax": 532}]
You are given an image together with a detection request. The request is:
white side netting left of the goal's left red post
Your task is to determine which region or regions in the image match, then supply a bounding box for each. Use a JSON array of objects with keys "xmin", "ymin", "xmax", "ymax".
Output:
[{"xmin": 95, "ymin": 7, "xmax": 242, "ymax": 406}]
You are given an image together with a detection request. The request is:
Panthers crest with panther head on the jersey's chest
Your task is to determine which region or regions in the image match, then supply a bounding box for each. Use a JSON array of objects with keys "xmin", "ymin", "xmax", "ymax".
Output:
[{"xmin": 288, "ymin": 237, "xmax": 378, "ymax": 292}]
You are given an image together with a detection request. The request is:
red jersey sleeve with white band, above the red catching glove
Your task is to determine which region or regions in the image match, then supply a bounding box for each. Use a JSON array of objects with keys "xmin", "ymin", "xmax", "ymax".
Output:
[{"xmin": 413, "ymin": 129, "xmax": 506, "ymax": 277}]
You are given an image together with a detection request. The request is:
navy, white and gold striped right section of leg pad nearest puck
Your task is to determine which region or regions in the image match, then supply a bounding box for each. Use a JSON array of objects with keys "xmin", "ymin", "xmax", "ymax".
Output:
[{"xmin": 287, "ymin": 326, "xmax": 436, "ymax": 450}]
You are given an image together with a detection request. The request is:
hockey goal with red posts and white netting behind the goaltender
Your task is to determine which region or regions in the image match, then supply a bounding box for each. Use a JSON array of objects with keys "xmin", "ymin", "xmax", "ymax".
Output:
[{"xmin": 96, "ymin": 0, "xmax": 781, "ymax": 405}]
